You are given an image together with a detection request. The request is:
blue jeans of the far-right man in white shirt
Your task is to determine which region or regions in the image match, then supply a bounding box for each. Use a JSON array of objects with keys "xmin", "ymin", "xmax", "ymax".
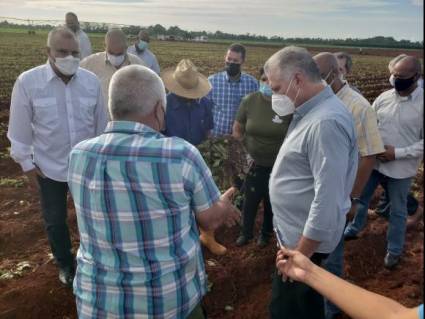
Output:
[{"xmin": 344, "ymin": 170, "xmax": 412, "ymax": 256}]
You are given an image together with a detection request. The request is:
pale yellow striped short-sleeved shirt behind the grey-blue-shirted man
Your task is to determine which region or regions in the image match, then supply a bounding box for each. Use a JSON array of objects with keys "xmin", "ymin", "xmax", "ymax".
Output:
[{"xmin": 336, "ymin": 84, "xmax": 385, "ymax": 157}]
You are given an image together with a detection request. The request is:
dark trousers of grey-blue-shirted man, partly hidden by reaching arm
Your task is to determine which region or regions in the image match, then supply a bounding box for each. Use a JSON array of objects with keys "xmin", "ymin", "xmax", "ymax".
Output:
[{"xmin": 269, "ymin": 253, "xmax": 328, "ymax": 319}]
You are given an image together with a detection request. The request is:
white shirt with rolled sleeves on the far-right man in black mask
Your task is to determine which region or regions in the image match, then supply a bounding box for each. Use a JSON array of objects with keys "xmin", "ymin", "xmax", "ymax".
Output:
[{"xmin": 372, "ymin": 87, "xmax": 424, "ymax": 178}]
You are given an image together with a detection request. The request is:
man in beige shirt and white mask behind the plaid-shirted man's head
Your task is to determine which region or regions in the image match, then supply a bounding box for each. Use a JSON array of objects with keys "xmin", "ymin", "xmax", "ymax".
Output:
[{"xmin": 80, "ymin": 28, "xmax": 145, "ymax": 113}]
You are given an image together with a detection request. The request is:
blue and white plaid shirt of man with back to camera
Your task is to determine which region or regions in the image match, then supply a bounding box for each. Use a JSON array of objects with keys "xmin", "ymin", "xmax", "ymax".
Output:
[{"xmin": 68, "ymin": 121, "xmax": 220, "ymax": 319}]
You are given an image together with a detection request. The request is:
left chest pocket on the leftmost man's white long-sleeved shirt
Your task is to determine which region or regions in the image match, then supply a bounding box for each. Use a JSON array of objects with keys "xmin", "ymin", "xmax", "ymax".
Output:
[{"xmin": 33, "ymin": 97, "xmax": 59, "ymax": 133}]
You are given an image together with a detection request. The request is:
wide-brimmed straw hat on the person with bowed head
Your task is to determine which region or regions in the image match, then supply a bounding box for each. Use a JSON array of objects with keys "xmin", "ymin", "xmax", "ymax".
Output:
[{"xmin": 161, "ymin": 59, "xmax": 211, "ymax": 99}]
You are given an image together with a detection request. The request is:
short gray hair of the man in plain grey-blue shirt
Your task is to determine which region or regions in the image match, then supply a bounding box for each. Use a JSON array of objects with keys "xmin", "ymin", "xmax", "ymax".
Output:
[{"xmin": 264, "ymin": 46, "xmax": 322, "ymax": 82}]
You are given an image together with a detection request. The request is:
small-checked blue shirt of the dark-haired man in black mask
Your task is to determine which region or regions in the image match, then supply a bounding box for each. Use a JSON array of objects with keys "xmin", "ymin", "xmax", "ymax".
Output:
[{"xmin": 208, "ymin": 71, "xmax": 258, "ymax": 136}]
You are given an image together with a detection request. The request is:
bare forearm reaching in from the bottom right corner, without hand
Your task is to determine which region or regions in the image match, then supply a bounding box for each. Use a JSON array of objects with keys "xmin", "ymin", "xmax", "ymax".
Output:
[{"xmin": 305, "ymin": 265, "xmax": 414, "ymax": 319}]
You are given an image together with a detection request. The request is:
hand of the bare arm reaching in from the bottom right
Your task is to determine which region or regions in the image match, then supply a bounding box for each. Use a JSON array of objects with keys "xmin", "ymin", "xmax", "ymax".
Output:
[{"xmin": 276, "ymin": 248, "xmax": 314, "ymax": 282}]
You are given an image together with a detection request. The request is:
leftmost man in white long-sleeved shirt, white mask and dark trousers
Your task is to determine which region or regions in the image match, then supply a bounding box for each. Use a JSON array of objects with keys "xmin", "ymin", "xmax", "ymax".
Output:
[{"xmin": 7, "ymin": 27, "xmax": 107, "ymax": 286}]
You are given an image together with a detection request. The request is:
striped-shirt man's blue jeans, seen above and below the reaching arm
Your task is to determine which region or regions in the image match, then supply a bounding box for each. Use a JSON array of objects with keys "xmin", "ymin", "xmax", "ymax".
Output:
[{"xmin": 323, "ymin": 236, "xmax": 344, "ymax": 319}]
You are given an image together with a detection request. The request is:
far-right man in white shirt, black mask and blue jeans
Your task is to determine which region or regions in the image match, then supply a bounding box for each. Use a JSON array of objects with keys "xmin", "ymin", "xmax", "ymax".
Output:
[{"xmin": 344, "ymin": 56, "xmax": 424, "ymax": 269}]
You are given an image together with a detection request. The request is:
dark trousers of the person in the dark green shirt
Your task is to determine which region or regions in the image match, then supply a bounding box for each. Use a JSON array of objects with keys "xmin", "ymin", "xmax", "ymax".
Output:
[{"xmin": 242, "ymin": 163, "xmax": 273, "ymax": 238}]
